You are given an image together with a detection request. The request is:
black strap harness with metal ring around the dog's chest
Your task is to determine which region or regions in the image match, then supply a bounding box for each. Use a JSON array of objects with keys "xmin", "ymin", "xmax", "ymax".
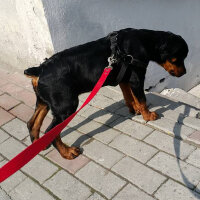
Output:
[{"xmin": 107, "ymin": 31, "xmax": 148, "ymax": 83}]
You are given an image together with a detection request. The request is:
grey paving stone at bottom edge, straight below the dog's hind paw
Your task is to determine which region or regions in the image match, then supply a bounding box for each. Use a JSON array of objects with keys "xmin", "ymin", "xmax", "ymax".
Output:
[{"xmin": 44, "ymin": 170, "xmax": 91, "ymax": 200}]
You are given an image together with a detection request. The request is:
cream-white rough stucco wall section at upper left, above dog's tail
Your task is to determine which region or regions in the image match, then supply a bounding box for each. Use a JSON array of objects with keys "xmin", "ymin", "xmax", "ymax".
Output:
[{"xmin": 0, "ymin": 0, "xmax": 53, "ymax": 72}]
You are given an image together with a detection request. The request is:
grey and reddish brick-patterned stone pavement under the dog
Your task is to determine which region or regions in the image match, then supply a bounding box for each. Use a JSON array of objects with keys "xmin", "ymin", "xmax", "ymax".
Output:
[{"xmin": 0, "ymin": 70, "xmax": 200, "ymax": 200}]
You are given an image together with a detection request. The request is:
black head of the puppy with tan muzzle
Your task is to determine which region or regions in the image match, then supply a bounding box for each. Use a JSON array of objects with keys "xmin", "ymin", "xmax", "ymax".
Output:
[{"xmin": 159, "ymin": 32, "xmax": 188, "ymax": 77}]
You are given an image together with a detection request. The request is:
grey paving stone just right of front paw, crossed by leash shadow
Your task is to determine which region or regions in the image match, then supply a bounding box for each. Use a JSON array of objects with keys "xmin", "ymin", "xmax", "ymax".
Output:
[{"xmin": 148, "ymin": 118, "xmax": 195, "ymax": 139}]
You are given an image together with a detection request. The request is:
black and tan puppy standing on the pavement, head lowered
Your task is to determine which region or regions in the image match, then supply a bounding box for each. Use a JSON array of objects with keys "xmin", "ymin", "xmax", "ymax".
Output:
[{"xmin": 24, "ymin": 28, "xmax": 188, "ymax": 159}]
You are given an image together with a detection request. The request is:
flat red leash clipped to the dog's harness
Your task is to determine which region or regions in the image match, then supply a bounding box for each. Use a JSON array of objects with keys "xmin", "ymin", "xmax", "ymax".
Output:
[{"xmin": 0, "ymin": 66, "xmax": 112, "ymax": 183}]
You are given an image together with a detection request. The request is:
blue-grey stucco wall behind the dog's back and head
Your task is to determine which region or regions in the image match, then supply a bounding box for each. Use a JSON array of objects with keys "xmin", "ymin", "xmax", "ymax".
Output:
[{"xmin": 42, "ymin": 0, "xmax": 200, "ymax": 91}]
